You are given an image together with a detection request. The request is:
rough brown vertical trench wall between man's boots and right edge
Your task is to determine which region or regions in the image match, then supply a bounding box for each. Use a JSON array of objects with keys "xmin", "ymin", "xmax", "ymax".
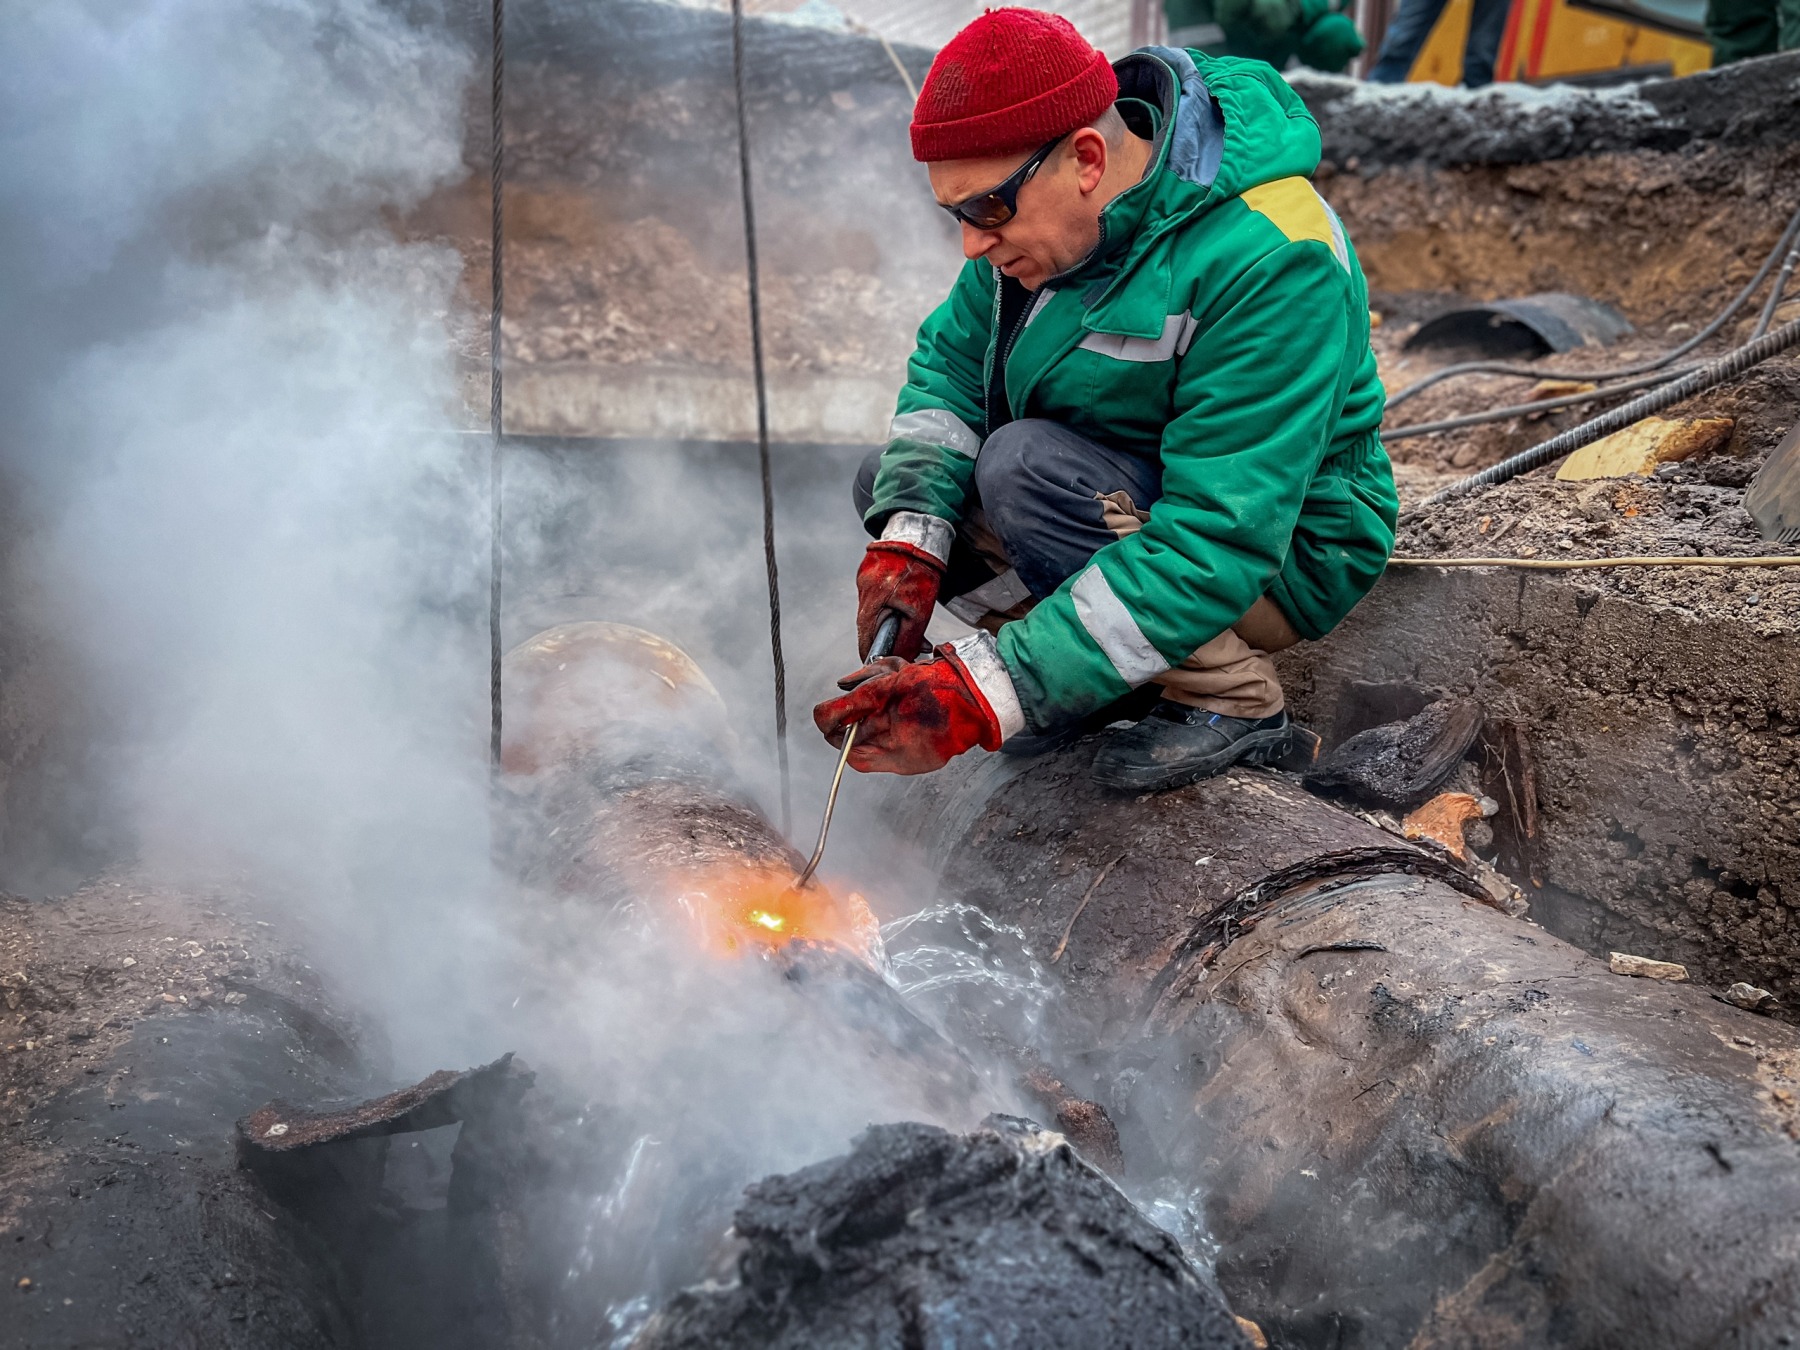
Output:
[{"xmin": 1282, "ymin": 569, "xmax": 1800, "ymax": 1008}]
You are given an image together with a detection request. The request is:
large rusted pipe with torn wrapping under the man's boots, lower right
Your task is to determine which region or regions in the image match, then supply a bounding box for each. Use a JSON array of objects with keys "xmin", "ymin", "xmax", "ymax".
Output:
[{"xmin": 896, "ymin": 756, "xmax": 1800, "ymax": 1348}]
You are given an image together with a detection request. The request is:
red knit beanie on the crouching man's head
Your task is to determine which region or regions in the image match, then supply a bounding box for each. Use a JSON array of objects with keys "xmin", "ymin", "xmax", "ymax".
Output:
[{"xmin": 913, "ymin": 9, "xmax": 1120, "ymax": 164}]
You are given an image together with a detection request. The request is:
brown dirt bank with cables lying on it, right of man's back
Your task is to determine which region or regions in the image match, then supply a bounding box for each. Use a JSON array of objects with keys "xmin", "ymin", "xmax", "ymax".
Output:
[{"xmin": 1303, "ymin": 58, "xmax": 1800, "ymax": 634}]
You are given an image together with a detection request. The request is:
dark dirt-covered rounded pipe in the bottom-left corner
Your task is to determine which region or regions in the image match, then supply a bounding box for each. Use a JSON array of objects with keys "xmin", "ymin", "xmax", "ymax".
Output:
[{"xmin": 0, "ymin": 986, "xmax": 370, "ymax": 1350}]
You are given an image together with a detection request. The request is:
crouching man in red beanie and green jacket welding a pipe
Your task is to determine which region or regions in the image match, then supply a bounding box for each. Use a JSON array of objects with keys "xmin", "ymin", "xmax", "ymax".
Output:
[{"xmin": 814, "ymin": 9, "xmax": 1397, "ymax": 792}]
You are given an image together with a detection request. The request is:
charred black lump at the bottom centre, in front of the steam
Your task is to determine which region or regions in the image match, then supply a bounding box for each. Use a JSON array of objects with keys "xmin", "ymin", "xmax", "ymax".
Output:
[{"xmin": 634, "ymin": 1116, "xmax": 1247, "ymax": 1350}]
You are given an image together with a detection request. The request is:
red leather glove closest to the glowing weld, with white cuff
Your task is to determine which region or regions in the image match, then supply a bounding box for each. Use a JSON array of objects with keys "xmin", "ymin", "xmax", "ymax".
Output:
[{"xmin": 812, "ymin": 644, "xmax": 1001, "ymax": 774}]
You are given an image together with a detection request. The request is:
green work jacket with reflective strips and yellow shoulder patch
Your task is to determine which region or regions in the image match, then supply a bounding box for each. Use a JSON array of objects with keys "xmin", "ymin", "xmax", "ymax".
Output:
[{"xmin": 866, "ymin": 47, "xmax": 1397, "ymax": 731}]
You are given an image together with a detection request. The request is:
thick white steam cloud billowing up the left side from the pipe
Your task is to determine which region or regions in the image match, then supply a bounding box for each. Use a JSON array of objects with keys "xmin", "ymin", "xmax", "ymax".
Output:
[{"xmin": 0, "ymin": 0, "xmax": 979, "ymax": 1332}]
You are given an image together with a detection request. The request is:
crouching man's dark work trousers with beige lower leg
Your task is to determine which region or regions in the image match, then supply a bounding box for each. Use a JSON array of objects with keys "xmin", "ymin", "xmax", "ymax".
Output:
[{"xmin": 853, "ymin": 418, "xmax": 1300, "ymax": 718}]
